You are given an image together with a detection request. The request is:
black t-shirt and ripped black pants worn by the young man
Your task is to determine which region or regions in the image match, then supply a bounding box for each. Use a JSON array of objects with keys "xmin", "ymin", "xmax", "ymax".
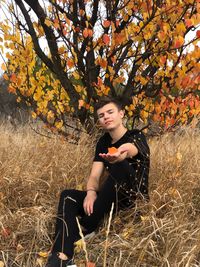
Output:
[{"xmin": 52, "ymin": 130, "xmax": 149, "ymax": 258}]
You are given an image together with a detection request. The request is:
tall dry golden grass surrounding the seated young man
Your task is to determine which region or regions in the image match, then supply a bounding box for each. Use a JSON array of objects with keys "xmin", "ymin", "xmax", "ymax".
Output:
[{"xmin": 0, "ymin": 124, "xmax": 200, "ymax": 267}]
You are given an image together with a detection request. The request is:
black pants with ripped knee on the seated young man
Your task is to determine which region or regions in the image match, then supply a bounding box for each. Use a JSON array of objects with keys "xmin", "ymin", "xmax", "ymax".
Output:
[{"xmin": 52, "ymin": 160, "xmax": 133, "ymax": 258}]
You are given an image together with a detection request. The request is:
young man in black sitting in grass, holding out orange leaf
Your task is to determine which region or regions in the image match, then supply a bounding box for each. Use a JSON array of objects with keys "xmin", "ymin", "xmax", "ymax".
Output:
[{"xmin": 46, "ymin": 97, "xmax": 149, "ymax": 267}]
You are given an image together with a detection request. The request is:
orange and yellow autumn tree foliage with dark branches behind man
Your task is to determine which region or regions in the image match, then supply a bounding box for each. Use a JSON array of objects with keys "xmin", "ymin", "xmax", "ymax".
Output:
[{"xmin": 0, "ymin": 0, "xmax": 200, "ymax": 133}]
